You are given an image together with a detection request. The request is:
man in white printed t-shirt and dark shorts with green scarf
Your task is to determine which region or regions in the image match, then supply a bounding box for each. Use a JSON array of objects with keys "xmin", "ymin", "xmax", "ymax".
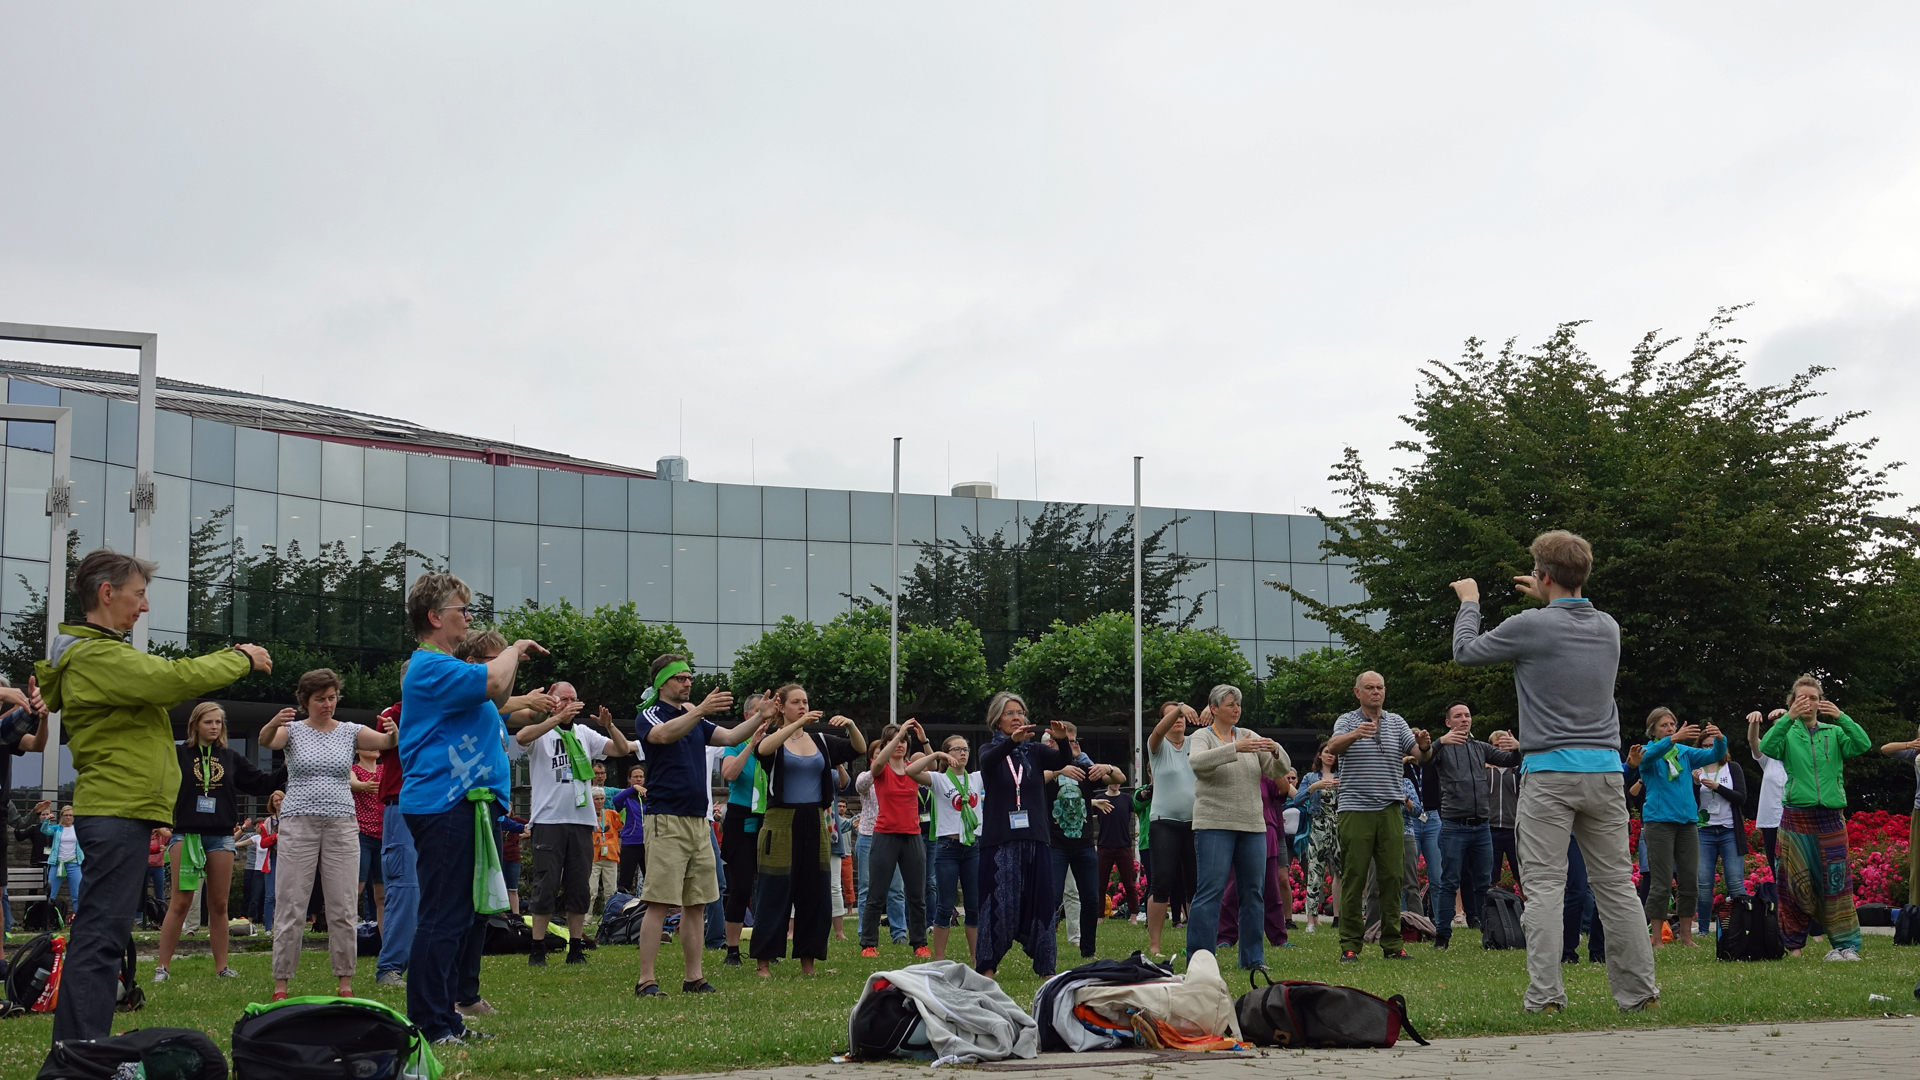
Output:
[{"xmin": 509, "ymin": 682, "xmax": 634, "ymax": 967}]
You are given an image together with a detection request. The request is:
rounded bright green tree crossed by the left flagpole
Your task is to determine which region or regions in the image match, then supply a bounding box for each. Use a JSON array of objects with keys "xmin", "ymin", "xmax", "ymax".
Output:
[{"xmin": 732, "ymin": 605, "xmax": 991, "ymax": 723}]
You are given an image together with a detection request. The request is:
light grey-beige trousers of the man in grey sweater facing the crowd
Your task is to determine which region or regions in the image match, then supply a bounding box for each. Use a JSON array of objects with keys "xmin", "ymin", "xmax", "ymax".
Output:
[{"xmin": 1515, "ymin": 773, "xmax": 1661, "ymax": 1013}]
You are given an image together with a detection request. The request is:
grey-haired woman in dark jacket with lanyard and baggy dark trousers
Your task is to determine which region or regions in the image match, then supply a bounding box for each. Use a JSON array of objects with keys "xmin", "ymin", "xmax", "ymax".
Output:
[{"xmin": 975, "ymin": 690, "xmax": 1073, "ymax": 978}]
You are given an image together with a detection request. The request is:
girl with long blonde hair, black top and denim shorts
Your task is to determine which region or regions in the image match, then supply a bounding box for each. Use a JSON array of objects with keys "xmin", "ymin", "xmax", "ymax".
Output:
[{"xmin": 154, "ymin": 701, "xmax": 280, "ymax": 982}]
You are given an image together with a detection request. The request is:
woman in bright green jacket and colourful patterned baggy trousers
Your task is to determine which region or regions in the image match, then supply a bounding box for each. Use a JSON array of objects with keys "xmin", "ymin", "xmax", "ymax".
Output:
[{"xmin": 1761, "ymin": 675, "xmax": 1874, "ymax": 961}]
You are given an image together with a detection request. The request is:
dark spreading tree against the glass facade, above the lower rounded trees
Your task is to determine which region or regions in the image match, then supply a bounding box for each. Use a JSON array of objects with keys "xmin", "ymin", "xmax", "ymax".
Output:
[{"xmin": 879, "ymin": 503, "xmax": 1206, "ymax": 669}]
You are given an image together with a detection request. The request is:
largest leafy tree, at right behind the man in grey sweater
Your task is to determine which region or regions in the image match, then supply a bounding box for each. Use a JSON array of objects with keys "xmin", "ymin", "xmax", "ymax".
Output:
[{"xmin": 1294, "ymin": 311, "xmax": 1910, "ymax": 799}]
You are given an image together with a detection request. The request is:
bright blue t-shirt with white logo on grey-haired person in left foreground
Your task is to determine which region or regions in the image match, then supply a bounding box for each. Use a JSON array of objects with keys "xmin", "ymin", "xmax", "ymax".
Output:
[{"xmin": 399, "ymin": 650, "xmax": 513, "ymax": 813}]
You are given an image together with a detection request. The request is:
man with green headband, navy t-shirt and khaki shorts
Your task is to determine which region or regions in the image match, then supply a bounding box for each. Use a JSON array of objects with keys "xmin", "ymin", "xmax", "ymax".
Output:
[{"xmin": 634, "ymin": 653, "xmax": 758, "ymax": 997}]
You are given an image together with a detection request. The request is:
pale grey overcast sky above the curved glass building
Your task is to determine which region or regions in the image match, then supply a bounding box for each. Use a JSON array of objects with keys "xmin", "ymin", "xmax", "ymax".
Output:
[{"xmin": 0, "ymin": 0, "xmax": 1920, "ymax": 511}]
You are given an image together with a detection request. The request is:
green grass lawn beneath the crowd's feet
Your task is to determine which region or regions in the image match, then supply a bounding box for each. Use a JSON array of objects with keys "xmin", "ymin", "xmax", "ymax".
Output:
[{"xmin": 0, "ymin": 922, "xmax": 1920, "ymax": 1080}]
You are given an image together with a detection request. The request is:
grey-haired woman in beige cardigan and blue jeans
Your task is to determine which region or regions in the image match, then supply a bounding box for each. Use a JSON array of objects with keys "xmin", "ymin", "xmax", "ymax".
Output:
[{"xmin": 1187, "ymin": 684, "xmax": 1294, "ymax": 970}]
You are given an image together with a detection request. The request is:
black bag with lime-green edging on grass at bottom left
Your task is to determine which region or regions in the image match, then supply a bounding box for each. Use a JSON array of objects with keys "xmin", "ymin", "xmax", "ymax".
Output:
[{"xmin": 234, "ymin": 997, "xmax": 442, "ymax": 1080}]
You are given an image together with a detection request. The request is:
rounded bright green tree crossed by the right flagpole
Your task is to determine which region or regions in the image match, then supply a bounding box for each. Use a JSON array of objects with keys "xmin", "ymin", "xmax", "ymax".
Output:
[{"xmin": 1000, "ymin": 611, "xmax": 1256, "ymax": 724}]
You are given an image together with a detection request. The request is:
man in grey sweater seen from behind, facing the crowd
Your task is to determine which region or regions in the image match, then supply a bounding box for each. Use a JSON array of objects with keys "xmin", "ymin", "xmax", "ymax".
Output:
[{"xmin": 1453, "ymin": 530, "xmax": 1659, "ymax": 1013}]
